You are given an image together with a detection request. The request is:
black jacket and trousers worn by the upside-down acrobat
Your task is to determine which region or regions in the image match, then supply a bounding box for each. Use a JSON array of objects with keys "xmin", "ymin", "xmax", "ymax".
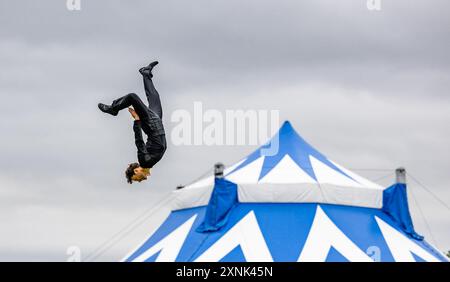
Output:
[{"xmin": 111, "ymin": 75, "xmax": 167, "ymax": 168}]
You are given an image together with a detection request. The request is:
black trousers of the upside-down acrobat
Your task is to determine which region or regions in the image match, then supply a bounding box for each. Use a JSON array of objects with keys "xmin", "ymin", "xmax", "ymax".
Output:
[{"xmin": 111, "ymin": 75, "xmax": 162, "ymax": 120}]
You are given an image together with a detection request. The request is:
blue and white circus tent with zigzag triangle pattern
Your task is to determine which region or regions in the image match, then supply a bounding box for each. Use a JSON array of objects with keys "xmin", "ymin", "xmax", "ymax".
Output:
[{"xmin": 124, "ymin": 122, "xmax": 447, "ymax": 262}]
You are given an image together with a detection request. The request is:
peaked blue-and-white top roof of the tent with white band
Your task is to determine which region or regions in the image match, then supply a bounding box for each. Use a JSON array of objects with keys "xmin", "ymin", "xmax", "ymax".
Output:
[{"xmin": 174, "ymin": 121, "xmax": 384, "ymax": 209}]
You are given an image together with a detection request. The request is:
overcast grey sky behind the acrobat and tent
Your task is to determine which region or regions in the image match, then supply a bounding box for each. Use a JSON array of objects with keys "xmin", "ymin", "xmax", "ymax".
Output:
[{"xmin": 0, "ymin": 0, "xmax": 450, "ymax": 261}]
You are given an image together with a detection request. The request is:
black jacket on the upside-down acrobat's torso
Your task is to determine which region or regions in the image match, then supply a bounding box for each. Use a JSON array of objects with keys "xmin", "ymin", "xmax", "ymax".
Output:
[{"xmin": 133, "ymin": 118, "xmax": 167, "ymax": 168}]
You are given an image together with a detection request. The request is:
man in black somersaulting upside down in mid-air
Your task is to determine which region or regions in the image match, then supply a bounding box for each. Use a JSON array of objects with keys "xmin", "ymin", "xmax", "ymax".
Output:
[{"xmin": 98, "ymin": 61, "xmax": 167, "ymax": 184}]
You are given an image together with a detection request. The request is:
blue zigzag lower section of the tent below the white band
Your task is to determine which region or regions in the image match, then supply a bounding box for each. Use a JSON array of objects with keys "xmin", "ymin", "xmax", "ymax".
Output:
[{"xmin": 127, "ymin": 203, "xmax": 445, "ymax": 262}]
